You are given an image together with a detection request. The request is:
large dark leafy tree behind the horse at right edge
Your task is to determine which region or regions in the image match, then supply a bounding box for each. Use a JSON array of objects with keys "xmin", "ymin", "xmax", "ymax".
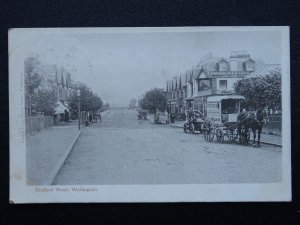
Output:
[{"xmin": 234, "ymin": 69, "xmax": 281, "ymax": 111}]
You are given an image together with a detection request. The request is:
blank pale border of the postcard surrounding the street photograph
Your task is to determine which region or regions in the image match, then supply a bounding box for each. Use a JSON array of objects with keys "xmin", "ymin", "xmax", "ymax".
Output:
[{"xmin": 9, "ymin": 26, "xmax": 291, "ymax": 203}]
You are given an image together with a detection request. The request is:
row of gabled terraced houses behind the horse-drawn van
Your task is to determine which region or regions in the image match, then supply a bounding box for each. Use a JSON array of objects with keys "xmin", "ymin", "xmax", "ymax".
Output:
[{"xmin": 166, "ymin": 51, "xmax": 279, "ymax": 117}]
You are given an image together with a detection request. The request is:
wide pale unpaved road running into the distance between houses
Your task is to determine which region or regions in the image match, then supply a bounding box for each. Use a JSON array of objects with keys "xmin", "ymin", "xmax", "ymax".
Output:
[{"xmin": 54, "ymin": 109, "xmax": 282, "ymax": 185}]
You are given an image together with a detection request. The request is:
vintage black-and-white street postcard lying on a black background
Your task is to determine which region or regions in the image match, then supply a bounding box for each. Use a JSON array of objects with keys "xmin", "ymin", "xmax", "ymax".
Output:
[{"xmin": 8, "ymin": 26, "xmax": 292, "ymax": 203}]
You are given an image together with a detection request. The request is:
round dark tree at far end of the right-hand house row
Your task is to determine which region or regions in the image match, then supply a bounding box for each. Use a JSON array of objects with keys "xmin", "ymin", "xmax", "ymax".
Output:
[{"xmin": 139, "ymin": 88, "xmax": 167, "ymax": 114}]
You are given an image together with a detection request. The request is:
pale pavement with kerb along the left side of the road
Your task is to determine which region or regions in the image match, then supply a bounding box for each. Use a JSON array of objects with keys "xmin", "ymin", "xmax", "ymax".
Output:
[{"xmin": 26, "ymin": 121, "xmax": 80, "ymax": 185}]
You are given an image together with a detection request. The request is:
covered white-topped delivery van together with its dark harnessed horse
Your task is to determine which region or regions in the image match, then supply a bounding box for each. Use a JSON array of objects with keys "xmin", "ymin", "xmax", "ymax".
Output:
[{"xmin": 203, "ymin": 95, "xmax": 267, "ymax": 145}]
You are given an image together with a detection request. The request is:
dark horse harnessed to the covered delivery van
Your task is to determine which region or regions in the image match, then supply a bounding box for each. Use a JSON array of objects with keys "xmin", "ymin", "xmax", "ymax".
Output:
[{"xmin": 237, "ymin": 108, "xmax": 268, "ymax": 147}]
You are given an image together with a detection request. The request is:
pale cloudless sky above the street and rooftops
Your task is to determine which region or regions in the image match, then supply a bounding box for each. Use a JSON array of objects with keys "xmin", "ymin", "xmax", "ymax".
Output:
[{"xmin": 12, "ymin": 29, "xmax": 282, "ymax": 106}]
